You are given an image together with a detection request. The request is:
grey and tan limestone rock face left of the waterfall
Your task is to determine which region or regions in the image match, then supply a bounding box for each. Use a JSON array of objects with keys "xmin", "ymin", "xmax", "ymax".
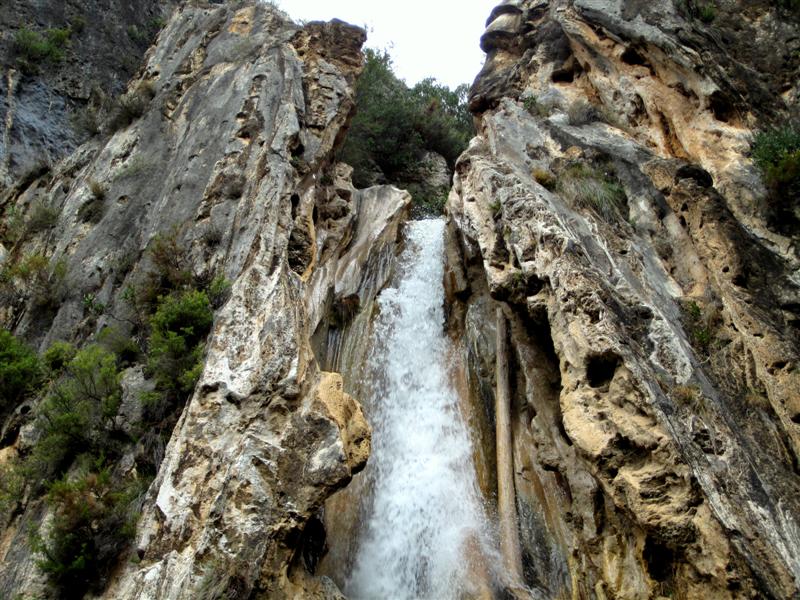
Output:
[{"xmin": 0, "ymin": 2, "xmax": 410, "ymax": 599}]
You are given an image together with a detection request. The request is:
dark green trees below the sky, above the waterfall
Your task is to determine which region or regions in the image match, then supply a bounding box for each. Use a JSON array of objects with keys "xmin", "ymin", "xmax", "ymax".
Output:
[{"xmin": 340, "ymin": 49, "xmax": 473, "ymax": 187}]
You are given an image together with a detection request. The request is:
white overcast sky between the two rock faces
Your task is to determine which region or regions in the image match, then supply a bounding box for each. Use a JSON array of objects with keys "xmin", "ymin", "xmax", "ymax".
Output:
[{"xmin": 276, "ymin": 0, "xmax": 500, "ymax": 88}]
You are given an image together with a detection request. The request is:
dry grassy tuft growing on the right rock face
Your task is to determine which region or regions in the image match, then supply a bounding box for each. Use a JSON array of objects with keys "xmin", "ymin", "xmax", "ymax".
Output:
[{"xmin": 556, "ymin": 162, "xmax": 627, "ymax": 221}]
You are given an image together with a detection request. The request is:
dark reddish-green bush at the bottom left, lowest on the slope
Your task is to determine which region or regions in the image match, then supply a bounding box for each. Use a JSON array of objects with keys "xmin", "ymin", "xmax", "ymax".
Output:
[{"xmin": 32, "ymin": 468, "xmax": 148, "ymax": 598}]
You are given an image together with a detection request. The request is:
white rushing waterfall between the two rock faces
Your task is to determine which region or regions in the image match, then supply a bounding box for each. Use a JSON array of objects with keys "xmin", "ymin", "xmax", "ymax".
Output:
[{"xmin": 345, "ymin": 220, "xmax": 499, "ymax": 600}]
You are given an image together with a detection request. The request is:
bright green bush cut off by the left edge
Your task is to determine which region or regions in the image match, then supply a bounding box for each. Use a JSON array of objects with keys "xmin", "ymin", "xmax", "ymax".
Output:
[{"xmin": 0, "ymin": 329, "xmax": 42, "ymax": 416}]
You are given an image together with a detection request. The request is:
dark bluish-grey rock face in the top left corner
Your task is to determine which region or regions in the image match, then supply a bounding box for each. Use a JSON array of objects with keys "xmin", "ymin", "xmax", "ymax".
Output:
[{"xmin": 0, "ymin": 0, "xmax": 178, "ymax": 189}]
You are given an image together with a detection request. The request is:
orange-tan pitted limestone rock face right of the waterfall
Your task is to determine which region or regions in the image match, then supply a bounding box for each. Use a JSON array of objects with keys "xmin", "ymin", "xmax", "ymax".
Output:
[{"xmin": 446, "ymin": 0, "xmax": 800, "ymax": 599}]
